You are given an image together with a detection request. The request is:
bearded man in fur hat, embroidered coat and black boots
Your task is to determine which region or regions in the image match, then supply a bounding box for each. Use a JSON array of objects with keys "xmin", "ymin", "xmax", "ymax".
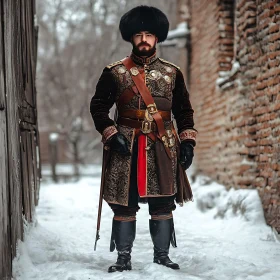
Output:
[{"xmin": 90, "ymin": 6, "xmax": 196, "ymax": 272}]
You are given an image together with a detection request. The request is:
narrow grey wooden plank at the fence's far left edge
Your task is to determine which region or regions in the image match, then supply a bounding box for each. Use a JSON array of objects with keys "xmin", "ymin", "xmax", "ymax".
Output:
[{"xmin": 0, "ymin": 1, "xmax": 12, "ymax": 279}]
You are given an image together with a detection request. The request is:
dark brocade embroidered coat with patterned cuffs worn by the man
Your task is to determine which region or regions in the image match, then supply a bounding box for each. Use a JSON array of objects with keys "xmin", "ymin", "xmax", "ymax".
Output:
[{"xmin": 90, "ymin": 53, "xmax": 196, "ymax": 206}]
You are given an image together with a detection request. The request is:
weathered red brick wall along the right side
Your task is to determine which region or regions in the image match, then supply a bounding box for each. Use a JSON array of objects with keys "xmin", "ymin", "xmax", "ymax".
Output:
[{"xmin": 187, "ymin": 0, "xmax": 280, "ymax": 232}]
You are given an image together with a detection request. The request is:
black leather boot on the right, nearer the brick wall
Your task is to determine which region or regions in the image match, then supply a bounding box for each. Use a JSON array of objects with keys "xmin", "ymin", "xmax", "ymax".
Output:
[{"xmin": 150, "ymin": 218, "xmax": 180, "ymax": 269}]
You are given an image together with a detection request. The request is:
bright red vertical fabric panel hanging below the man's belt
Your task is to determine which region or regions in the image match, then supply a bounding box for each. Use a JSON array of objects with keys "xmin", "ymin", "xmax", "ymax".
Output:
[{"xmin": 137, "ymin": 134, "xmax": 147, "ymax": 197}]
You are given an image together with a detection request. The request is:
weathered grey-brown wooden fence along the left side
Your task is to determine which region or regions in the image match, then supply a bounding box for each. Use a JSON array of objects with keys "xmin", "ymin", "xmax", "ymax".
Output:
[{"xmin": 0, "ymin": 0, "xmax": 41, "ymax": 280}]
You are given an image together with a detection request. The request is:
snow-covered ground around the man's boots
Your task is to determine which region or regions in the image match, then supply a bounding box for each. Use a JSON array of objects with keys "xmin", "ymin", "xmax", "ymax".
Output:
[{"xmin": 13, "ymin": 168, "xmax": 280, "ymax": 280}]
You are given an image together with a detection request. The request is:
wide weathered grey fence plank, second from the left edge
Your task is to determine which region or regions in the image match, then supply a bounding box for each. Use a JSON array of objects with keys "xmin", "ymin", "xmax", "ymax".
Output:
[{"xmin": 3, "ymin": 0, "xmax": 23, "ymax": 257}]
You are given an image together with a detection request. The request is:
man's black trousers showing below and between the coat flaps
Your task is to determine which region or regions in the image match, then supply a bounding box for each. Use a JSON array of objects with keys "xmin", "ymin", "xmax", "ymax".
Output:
[{"xmin": 109, "ymin": 139, "xmax": 176, "ymax": 216}]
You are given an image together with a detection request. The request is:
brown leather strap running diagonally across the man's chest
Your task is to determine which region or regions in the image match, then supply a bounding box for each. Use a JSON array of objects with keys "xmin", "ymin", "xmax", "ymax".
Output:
[{"xmin": 122, "ymin": 57, "xmax": 171, "ymax": 158}]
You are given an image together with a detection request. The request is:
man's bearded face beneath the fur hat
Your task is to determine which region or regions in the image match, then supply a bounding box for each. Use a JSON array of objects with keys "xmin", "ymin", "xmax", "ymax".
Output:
[{"xmin": 132, "ymin": 31, "xmax": 157, "ymax": 56}]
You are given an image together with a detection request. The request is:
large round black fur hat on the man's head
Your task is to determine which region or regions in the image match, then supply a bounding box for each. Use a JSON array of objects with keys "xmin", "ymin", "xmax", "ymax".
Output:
[{"xmin": 119, "ymin": 6, "xmax": 169, "ymax": 43}]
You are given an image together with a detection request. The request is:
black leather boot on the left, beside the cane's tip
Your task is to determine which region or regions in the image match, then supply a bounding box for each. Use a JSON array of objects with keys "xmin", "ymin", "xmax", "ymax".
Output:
[{"xmin": 108, "ymin": 220, "xmax": 136, "ymax": 272}]
